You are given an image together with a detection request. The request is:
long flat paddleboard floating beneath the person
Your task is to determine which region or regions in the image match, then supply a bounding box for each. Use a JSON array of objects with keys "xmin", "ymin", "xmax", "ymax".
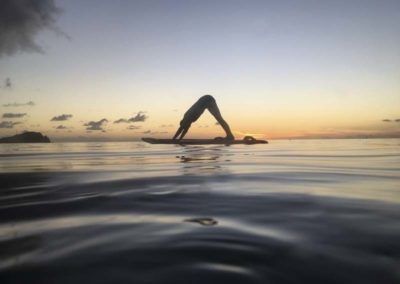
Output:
[{"xmin": 142, "ymin": 136, "xmax": 268, "ymax": 145}]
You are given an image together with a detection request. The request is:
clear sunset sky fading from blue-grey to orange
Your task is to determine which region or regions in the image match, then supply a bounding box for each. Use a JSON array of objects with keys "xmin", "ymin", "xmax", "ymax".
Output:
[{"xmin": 0, "ymin": 0, "xmax": 400, "ymax": 141}]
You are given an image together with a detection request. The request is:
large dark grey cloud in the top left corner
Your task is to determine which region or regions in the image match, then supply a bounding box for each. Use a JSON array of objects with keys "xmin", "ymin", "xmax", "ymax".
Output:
[{"xmin": 0, "ymin": 0, "xmax": 62, "ymax": 57}]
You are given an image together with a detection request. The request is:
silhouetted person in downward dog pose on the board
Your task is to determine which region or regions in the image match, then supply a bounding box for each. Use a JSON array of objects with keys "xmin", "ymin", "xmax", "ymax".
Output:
[{"xmin": 173, "ymin": 95, "xmax": 235, "ymax": 140}]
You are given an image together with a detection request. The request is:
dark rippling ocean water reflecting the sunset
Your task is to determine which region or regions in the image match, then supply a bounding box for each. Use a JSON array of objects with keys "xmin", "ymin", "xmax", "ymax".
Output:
[{"xmin": 0, "ymin": 139, "xmax": 400, "ymax": 284}]
